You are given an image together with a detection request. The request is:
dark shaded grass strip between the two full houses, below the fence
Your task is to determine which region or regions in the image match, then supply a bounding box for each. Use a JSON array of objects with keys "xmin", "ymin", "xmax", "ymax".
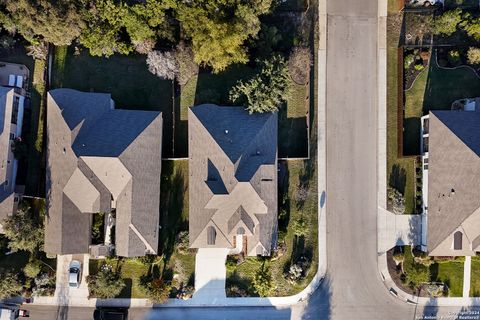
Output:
[{"xmin": 158, "ymin": 161, "xmax": 188, "ymax": 264}]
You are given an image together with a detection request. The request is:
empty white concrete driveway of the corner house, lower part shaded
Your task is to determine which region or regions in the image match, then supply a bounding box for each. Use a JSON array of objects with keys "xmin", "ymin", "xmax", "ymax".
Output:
[{"xmin": 193, "ymin": 248, "xmax": 230, "ymax": 303}]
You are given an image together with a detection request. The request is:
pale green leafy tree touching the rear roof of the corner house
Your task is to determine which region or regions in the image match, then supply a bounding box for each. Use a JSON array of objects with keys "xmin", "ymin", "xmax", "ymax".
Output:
[{"xmin": 230, "ymin": 55, "xmax": 290, "ymax": 113}]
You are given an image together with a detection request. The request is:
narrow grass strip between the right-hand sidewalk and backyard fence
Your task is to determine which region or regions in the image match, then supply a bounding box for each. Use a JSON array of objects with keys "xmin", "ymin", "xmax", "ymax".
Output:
[{"xmin": 387, "ymin": 13, "xmax": 415, "ymax": 214}]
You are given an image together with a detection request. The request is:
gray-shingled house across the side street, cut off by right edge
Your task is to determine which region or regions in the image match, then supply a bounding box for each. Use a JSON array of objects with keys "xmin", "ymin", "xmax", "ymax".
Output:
[{"xmin": 421, "ymin": 106, "xmax": 480, "ymax": 256}]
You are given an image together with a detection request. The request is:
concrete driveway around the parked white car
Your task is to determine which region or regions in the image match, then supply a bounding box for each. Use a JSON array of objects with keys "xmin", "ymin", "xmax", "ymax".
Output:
[{"xmin": 55, "ymin": 254, "xmax": 89, "ymax": 305}]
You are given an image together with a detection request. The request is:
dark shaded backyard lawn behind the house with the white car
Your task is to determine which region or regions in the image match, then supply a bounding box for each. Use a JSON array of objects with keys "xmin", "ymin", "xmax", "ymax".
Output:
[{"xmin": 52, "ymin": 47, "xmax": 173, "ymax": 157}]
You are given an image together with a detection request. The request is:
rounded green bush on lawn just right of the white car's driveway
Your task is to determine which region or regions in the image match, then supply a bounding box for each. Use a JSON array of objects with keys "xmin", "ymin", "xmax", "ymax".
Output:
[{"xmin": 87, "ymin": 264, "xmax": 125, "ymax": 299}]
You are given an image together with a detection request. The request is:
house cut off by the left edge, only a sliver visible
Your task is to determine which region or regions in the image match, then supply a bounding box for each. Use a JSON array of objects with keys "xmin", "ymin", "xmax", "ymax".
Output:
[{"xmin": 0, "ymin": 87, "xmax": 25, "ymax": 225}]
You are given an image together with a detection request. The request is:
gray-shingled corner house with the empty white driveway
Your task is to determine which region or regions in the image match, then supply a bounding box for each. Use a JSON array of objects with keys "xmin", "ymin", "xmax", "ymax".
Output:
[{"xmin": 188, "ymin": 104, "xmax": 278, "ymax": 256}]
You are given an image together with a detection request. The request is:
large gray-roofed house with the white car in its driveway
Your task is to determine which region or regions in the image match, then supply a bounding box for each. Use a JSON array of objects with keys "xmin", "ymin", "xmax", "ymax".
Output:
[{"xmin": 45, "ymin": 89, "xmax": 163, "ymax": 257}]
